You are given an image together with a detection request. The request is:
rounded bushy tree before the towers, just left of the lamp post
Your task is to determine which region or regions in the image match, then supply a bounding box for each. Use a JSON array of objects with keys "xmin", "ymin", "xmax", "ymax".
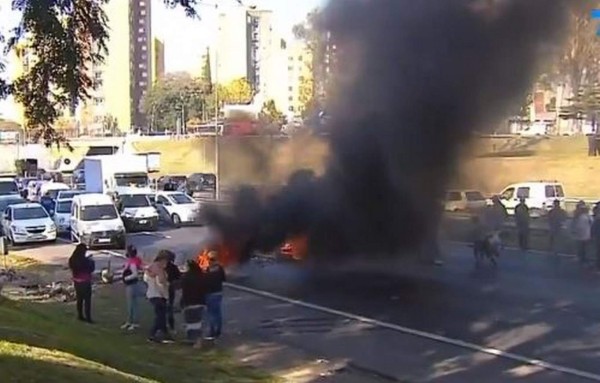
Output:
[{"xmin": 143, "ymin": 73, "xmax": 210, "ymax": 131}]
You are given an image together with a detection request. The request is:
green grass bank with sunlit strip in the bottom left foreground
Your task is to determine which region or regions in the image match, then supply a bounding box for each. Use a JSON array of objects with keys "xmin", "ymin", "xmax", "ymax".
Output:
[{"xmin": 0, "ymin": 284, "xmax": 273, "ymax": 383}]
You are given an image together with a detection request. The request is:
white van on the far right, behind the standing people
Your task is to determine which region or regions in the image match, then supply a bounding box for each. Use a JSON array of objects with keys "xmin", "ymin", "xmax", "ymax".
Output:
[{"xmin": 500, "ymin": 181, "xmax": 565, "ymax": 217}]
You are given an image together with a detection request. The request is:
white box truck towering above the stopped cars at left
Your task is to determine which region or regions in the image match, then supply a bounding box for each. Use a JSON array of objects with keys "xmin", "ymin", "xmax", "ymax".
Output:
[{"xmin": 83, "ymin": 154, "xmax": 148, "ymax": 194}]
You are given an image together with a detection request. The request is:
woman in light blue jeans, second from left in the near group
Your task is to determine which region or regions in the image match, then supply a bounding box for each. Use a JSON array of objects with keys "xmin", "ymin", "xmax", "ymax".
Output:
[{"xmin": 121, "ymin": 245, "xmax": 144, "ymax": 330}]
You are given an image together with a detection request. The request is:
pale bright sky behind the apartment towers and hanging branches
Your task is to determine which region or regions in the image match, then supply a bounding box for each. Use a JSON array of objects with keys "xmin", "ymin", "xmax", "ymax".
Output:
[{"xmin": 0, "ymin": 0, "xmax": 327, "ymax": 118}]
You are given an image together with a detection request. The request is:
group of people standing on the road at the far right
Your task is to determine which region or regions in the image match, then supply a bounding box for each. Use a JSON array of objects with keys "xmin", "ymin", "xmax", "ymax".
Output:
[{"xmin": 474, "ymin": 197, "xmax": 600, "ymax": 268}]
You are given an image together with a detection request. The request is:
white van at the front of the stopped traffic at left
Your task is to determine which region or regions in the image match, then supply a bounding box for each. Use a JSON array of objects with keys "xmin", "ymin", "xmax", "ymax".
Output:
[{"xmin": 71, "ymin": 193, "xmax": 125, "ymax": 249}]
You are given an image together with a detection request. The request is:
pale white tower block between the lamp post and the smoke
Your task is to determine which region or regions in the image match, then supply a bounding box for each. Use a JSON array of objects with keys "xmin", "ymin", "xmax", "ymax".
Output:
[{"xmin": 213, "ymin": 7, "xmax": 284, "ymax": 108}]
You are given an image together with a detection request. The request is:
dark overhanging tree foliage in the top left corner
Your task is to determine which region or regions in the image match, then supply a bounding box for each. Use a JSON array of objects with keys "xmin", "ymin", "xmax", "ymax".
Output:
[{"xmin": 0, "ymin": 0, "xmax": 202, "ymax": 145}]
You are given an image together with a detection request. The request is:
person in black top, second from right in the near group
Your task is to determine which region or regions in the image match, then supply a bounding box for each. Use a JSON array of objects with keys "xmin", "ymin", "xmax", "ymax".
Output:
[{"xmin": 181, "ymin": 259, "xmax": 206, "ymax": 345}]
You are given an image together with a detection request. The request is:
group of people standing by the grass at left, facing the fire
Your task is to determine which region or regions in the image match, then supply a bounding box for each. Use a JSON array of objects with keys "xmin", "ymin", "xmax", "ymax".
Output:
[{"xmin": 69, "ymin": 244, "xmax": 226, "ymax": 345}]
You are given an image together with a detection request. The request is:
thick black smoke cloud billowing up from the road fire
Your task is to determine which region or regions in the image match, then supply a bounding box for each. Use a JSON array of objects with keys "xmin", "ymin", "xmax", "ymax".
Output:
[{"xmin": 213, "ymin": 0, "xmax": 579, "ymax": 257}]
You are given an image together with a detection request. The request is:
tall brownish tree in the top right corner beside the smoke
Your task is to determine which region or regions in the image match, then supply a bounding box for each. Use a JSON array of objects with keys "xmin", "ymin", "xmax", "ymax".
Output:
[{"xmin": 554, "ymin": 1, "xmax": 600, "ymax": 95}]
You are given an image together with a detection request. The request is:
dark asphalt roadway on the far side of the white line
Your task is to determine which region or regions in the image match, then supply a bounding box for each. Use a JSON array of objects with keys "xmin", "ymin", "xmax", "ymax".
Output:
[{"xmin": 14, "ymin": 228, "xmax": 600, "ymax": 380}]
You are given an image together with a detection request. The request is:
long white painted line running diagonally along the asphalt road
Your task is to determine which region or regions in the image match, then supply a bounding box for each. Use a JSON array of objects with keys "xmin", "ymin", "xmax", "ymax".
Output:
[{"xmin": 225, "ymin": 283, "xmax": 600, "ymax": 382}]
